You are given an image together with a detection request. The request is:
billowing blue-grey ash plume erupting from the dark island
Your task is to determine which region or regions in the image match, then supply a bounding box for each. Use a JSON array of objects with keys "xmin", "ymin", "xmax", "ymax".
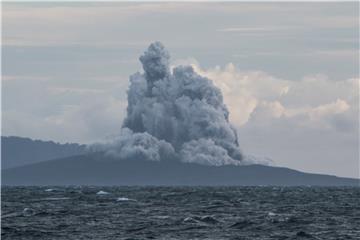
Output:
[{"xmin": 97, "ymin": 42, "xmax": 242, "ymax": 166}]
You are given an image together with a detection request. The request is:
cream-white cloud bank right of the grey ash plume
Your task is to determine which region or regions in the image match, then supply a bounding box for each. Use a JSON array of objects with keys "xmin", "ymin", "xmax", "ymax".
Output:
[{"xmin": 188, "ymin": 59, "xmax": 359, "ymax": 132}]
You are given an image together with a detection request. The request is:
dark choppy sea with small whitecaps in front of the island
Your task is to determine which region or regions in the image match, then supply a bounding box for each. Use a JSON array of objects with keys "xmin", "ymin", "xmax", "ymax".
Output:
[{"xmin": 1, "ymin": 186, "xmax": 360, "ymax": 240}]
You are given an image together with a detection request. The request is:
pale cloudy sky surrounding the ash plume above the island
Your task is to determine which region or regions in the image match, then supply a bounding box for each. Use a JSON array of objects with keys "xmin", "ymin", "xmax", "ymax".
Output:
[{"xmin": 1, "ymin": 2, "xmax": 360, "ymax": 177}]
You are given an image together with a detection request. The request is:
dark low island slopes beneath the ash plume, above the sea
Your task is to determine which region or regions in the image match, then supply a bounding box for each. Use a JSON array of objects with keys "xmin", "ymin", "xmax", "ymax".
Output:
[{"xmin": 1, "ymin": 138, "xmax": 359, "ymax": 186}]
